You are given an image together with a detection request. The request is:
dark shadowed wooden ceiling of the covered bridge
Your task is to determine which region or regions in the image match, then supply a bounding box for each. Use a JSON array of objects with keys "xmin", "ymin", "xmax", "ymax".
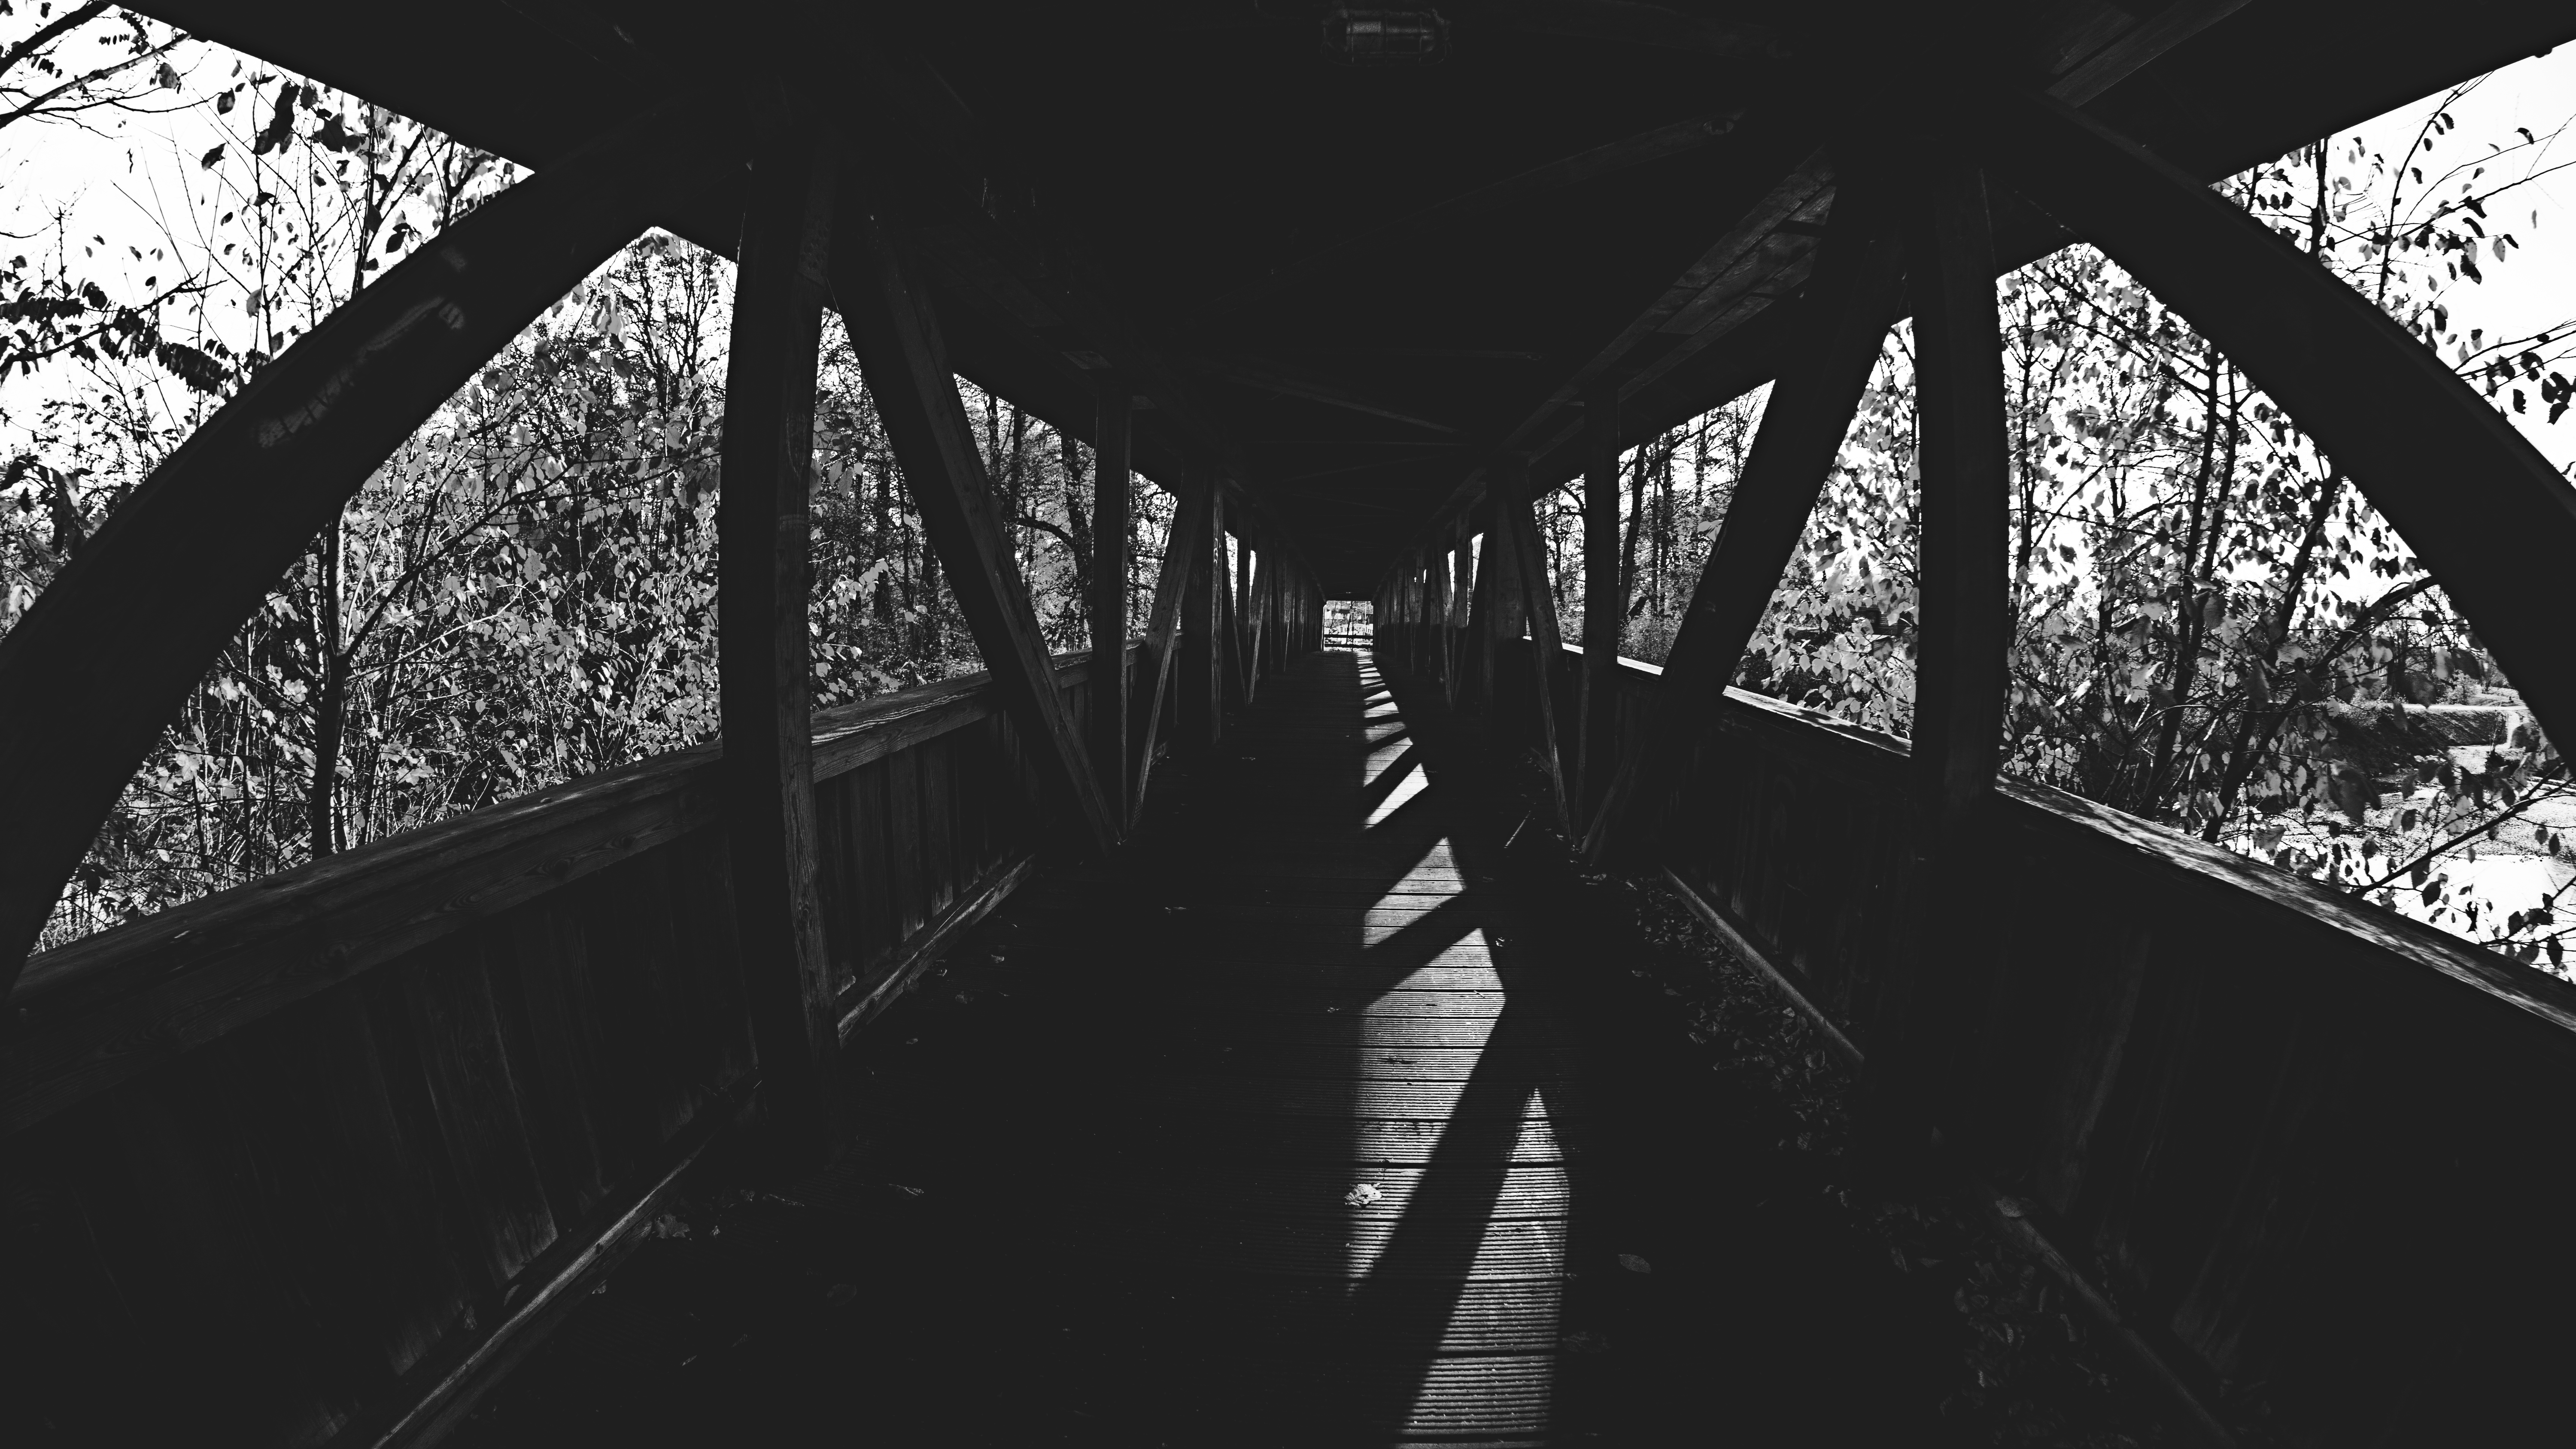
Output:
[{"xmin": 144, "ymin": 0, "xmax": 2576, "ymax": 597}]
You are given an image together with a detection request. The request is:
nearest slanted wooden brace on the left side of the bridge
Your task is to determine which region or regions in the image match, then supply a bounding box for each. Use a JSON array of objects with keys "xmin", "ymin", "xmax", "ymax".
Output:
[{"xmin": 832, "ymin": 195, "xmax": 1118, "ymax": 849}]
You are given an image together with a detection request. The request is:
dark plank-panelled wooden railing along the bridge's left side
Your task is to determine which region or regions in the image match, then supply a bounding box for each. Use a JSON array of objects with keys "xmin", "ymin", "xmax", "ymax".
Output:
[{"xmin": 0, "ymin": 646, "xmax": 1144, "ymax": 1444}]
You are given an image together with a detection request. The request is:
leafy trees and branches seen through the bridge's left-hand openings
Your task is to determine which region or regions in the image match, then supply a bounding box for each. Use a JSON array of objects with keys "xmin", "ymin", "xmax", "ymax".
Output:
[{"xmin": 0, "ymin": 20, "xmax": 1170, "ymax": 945}]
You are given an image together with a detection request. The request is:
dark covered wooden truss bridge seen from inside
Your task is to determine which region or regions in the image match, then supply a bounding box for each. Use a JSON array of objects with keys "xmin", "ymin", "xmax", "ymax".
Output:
[{"xmin": 0, "ymin": 0, "xmax": 2576, "ymax": 1444}]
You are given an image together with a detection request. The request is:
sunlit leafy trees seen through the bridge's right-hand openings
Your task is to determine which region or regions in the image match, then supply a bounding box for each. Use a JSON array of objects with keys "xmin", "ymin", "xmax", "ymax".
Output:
[{"xmin": 1543, "ymin": 82, "xmax": 2576, "ymax": 968}]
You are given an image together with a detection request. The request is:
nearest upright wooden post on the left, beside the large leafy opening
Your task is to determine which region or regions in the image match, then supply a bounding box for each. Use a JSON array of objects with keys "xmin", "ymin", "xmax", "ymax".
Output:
[{"xmin": 716, "ymin": 131, "xmax": 842, "ymax": 1161}]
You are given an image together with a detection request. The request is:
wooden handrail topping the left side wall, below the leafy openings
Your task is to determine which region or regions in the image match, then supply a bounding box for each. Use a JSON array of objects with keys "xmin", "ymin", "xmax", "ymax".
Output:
[{"xmin": 0, "ymin": 641, "xmax": 1141, "ymax": 1135}]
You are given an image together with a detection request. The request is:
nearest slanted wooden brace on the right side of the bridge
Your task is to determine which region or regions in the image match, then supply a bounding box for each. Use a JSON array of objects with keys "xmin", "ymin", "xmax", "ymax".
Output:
[{"xmin": 1584, "ymin": 178, "xmax": 1904, "ymax": 862}]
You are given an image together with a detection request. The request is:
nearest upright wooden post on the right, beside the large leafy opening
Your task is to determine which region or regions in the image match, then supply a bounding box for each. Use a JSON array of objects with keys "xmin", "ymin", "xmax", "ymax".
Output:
[{"xmin": 1862, "ymin": 157, "xmax": 2012, "ymax": 1161}]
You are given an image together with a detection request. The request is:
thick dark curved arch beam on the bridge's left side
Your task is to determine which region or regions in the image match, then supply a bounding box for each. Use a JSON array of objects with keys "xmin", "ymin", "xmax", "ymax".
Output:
[{"xmin": 0, "ymin": 100, "xmax": 742, "ymax": 996}]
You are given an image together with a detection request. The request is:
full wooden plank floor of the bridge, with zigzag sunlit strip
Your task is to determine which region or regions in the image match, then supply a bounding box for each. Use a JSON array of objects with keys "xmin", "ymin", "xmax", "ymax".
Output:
[{"xmin": 464, "ymin": 651, "xmax": 1945, "ymax": 1449}]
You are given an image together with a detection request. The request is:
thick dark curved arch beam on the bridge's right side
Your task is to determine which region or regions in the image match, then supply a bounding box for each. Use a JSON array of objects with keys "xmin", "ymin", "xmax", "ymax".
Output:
[{"xmin": 1976, "ymin": 95, "xmax": 2576, "ymax": 772}]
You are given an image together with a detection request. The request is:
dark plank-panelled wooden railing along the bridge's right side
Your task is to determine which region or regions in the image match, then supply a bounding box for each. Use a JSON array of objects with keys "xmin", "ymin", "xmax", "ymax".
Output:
[{"xmin": 1473, "ymin": 641, "xmax": 2576, "ymax": 1444}]
